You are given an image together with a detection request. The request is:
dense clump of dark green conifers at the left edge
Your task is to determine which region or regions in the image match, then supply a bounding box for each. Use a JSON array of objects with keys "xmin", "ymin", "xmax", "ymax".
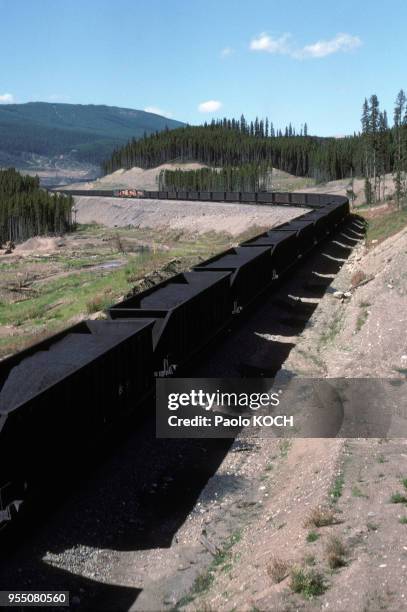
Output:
[{"xmin": 0, "ymin": 168, "xmax": 73, "ymax": 245}]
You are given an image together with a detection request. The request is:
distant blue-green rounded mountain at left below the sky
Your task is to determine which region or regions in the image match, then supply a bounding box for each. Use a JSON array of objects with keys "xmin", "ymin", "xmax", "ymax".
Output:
[{"xmin": 0, "ymin": 102, "xmax": 185, "ymax": 180}]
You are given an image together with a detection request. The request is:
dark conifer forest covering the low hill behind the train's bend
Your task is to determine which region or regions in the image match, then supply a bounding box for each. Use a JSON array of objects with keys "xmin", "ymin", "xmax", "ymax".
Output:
[{"xmin": 104, "ymin": 117, "xmax": 363, "ymax": 180}]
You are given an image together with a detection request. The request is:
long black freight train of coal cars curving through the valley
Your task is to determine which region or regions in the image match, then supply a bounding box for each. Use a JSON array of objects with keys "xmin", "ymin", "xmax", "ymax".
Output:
[{"xmin": 0, "ymin": 192, "xmax": 349, "ymax": 529}]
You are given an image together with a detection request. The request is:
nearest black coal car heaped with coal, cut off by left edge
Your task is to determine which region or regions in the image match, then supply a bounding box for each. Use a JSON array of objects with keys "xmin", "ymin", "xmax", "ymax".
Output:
[{"xmin": 0, "ymin": 321, "xmax": 153, "ymax": 529}]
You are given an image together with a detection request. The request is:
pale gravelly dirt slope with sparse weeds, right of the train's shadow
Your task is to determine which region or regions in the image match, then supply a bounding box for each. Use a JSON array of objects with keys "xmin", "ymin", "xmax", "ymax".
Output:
[{"xmin": 175, "ymin": 219, "xmax": 407, "ymax": 612}]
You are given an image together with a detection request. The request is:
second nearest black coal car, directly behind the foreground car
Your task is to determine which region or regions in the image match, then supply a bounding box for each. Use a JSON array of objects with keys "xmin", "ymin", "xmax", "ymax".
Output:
[{"xmin": 109, "ymin": 271, "xmax": 231, "ymax": 375}]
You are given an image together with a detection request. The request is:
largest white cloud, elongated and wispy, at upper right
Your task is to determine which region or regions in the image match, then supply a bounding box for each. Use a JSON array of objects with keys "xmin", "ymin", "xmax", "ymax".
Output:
[{"xmin": 250, "ymin": 32, "xmax": 362, "ymax": 59}]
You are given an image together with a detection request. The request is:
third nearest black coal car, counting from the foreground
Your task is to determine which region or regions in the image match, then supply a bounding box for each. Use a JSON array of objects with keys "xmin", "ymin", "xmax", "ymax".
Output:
[{"xmin": 194, "ymin": 247, "xmax": 273, "ymax": 312}]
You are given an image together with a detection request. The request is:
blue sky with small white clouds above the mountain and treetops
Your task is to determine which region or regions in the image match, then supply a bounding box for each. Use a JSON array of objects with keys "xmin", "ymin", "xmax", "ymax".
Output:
[{"xmin": 0, "ymin": 0, "xmax": 407, "ymax": 135}]
